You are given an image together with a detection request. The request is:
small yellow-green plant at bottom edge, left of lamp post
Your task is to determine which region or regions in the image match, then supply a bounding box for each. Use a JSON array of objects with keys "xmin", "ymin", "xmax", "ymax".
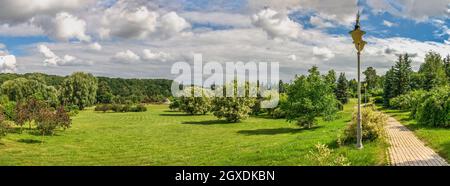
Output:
[{"xmin": 307, "ymin": 143, "xmax": 350, "ymax": 166}]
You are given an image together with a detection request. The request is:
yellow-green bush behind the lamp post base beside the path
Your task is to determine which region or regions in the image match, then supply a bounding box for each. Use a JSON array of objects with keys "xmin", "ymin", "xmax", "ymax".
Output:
[{"xmin": 343, "ymin": 107, "xmax": 388, "ymax": 142}]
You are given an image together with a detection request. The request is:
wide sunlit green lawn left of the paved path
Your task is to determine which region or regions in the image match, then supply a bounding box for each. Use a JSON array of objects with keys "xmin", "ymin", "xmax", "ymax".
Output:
[{"xmin": 0, "ymin": 100, "xmax": 386, "ymax": 165}]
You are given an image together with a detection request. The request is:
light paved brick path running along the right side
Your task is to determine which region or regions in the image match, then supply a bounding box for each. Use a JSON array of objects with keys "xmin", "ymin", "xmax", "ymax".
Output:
[{"xmin": 386, "ymin": 117, "xmax": 448, "ymax": 166}]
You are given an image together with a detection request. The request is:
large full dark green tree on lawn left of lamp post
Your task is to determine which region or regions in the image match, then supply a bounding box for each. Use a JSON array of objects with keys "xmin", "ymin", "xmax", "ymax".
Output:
[{"xmin": 284, "ymin": 66, "xmax": 338, "ymax": 128}]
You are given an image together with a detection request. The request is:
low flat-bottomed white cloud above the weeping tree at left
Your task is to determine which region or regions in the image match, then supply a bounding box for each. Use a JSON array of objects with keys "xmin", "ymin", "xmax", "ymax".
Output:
[{"xmin": 38, "ymin": 45, "xmax": 92, "ymax": 66}]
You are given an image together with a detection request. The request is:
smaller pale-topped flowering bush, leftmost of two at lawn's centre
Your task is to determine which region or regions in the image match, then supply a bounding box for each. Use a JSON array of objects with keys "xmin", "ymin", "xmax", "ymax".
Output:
[{"xmin": 179, "ymin": 86, "xmax": 212, "ymax": 115}]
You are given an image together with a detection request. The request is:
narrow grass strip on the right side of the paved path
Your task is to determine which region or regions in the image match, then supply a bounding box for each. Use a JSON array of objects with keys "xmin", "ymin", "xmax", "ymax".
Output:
[{"xmin": 379, "ymin": 107, "xmax": 450, "ymax": 161}]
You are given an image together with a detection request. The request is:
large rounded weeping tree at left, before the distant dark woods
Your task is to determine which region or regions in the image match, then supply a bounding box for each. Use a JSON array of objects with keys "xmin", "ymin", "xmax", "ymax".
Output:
[{"xmin": 60, "ymin": 72, "xmax": 98, "ymax": 110}]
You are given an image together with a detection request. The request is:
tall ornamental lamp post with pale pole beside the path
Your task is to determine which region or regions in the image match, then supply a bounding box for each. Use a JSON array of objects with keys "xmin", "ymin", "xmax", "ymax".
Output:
[{"xmin": 350, "ymin": 11, "xmax": 367, "ymax": 149}]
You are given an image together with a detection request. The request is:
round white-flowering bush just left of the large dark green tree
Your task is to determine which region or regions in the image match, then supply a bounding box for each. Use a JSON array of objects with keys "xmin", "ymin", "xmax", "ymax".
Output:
[{"xmin": 212, "ymin": 82, "xmax": 256, "ymax": 123}]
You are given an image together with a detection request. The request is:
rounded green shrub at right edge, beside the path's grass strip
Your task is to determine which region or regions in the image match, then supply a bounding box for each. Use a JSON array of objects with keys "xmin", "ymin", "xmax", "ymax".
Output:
[{"xmin": 417, "ymin": 88, "xmax": 450, "ymax": 127}]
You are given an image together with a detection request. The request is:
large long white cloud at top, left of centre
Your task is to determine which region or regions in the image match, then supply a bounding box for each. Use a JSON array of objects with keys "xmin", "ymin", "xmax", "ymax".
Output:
[{"xmin": 98, "ymin": 2, "xmax": 190, "ymax": 39}]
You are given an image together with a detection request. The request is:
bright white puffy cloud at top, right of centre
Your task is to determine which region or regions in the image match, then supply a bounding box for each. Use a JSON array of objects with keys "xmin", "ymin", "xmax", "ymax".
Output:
[{"xmin": 252, "ymin": 8, "xmax": 301, "ymax": 39}]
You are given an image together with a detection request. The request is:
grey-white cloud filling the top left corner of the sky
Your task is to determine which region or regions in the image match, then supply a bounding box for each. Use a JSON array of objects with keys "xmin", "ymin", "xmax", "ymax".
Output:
[{"xmin": 0, "ymin": 0, "xmax": 94, "ymax": 24}]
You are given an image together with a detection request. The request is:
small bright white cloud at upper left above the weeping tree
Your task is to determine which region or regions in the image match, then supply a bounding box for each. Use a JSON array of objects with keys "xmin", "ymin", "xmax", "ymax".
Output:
[{"xmin": 36, "ymin": 12, "xmax": 91, "ymax": 42}]
